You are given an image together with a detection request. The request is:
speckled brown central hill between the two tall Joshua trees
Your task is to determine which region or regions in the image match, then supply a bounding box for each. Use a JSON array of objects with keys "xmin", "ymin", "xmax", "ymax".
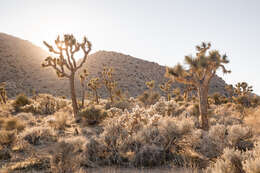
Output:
[{"xmin": 80, "ymin": 51, "xmax": 229, "ymax": 96}]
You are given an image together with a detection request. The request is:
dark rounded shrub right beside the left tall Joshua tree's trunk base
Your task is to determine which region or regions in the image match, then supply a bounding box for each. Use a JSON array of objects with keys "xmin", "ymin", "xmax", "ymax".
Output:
[{"xmin": 79, "ymin": 105, "xmax": 107, "ymax": 125}]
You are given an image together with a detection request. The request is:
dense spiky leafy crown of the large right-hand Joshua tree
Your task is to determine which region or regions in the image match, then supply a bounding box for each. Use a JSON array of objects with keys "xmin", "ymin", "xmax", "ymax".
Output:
[{"xmin": 166, "ymin": 42, "xmax": 230, "ymax": 86}]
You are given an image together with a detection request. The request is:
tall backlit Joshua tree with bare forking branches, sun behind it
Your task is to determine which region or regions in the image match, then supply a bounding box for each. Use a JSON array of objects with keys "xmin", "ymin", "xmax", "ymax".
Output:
[{"xmin": 42, "ymin": 34, "xmax": 92, "ymax": 116}]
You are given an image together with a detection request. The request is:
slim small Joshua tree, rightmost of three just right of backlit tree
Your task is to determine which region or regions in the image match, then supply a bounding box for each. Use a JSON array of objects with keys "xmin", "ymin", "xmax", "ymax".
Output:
[{"xmin": 102, "ymin": 67, "xmax": 117, "ymax": 103}]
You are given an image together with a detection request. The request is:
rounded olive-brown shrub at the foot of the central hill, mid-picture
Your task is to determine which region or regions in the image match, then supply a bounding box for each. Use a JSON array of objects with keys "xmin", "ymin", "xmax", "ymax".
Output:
[{"xmin": 138, "ymin": 91, "xmax": 160, "ymax": 106}]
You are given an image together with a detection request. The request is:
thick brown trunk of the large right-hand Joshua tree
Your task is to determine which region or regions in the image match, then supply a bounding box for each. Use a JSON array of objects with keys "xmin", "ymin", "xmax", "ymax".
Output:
[{"xmin": 198, "ymin": 86, "xmax": 209, "ymax": 130}]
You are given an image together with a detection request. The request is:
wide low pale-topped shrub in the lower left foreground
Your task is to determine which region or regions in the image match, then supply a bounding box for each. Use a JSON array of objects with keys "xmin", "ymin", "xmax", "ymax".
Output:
[{"xmin": 20, "ymin": 127, "xmax": 57, "ymax": 145}]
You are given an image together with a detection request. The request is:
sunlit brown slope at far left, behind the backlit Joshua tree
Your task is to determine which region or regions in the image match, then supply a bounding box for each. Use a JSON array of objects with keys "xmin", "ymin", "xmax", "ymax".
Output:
[{"xmin": 0, "ymin": 33, "xmax": 68, "ymax": 97}]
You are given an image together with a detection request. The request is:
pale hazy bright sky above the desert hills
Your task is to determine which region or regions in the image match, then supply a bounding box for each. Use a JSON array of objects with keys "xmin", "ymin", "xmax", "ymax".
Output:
[{"xmin": 0, "ymin": 0, "xmax": 260, "ymax": 94}]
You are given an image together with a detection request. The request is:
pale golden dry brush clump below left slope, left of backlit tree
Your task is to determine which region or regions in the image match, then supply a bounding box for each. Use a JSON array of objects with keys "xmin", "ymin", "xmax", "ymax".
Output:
[{"xmin": 20, "ymin": 94, "xmax": 68, "ymax": 115}]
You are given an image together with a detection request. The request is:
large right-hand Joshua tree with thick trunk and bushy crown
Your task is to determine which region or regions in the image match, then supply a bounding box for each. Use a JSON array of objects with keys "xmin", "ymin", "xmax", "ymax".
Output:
[{"xmin": 166, "ymin": 42, "xmax": 230, "ymax": 130}]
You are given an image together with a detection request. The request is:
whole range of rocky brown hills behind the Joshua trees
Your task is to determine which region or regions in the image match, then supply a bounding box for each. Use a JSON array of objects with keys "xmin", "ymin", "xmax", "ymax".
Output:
[{"xmin": 0, "ymin": 33, "xmax": 226, "ymax": 97}]
